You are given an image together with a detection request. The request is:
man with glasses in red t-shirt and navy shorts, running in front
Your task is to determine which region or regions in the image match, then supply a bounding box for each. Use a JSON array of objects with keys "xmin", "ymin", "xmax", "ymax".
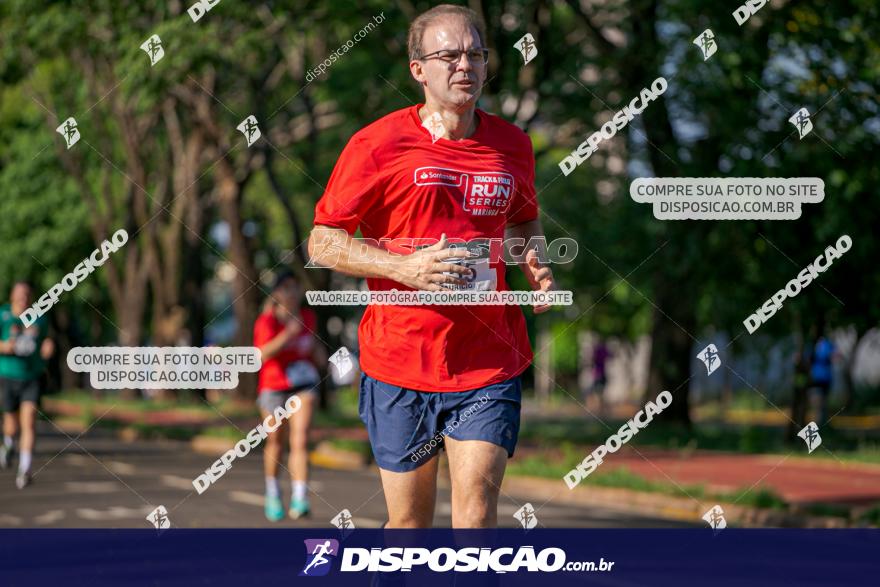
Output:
[{"xmin": 309, "ymin": 5, "xmax": 554, "ymax": 528}]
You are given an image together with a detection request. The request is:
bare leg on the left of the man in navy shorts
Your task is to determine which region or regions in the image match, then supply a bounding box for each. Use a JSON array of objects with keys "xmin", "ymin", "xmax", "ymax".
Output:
[{"xmin": 379, "ymin": 456, "xmax": 439, "ymax": 528}]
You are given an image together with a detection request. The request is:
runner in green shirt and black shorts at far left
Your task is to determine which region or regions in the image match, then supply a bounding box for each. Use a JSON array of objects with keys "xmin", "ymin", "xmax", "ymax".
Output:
[{"xmin": 0, "ymin": 281, "xmax": 54, "ymax": 489}]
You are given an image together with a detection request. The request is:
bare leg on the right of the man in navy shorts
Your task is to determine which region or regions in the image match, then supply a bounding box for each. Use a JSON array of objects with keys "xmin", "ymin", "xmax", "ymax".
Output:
[{"xmin": 443, "ymin": 436, "xmax": 507, "ymax": 528}]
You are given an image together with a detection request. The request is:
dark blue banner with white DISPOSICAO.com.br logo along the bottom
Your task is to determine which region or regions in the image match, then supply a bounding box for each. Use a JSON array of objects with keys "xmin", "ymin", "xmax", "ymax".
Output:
[{"xmin": 0, "ymin": 528, "xmax": 880, "ymax": 587}]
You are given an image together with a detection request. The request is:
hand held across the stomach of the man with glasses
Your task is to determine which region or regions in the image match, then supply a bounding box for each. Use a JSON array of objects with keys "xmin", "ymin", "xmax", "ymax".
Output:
[{"xmin": 388, "ymin": 233, "xmax": 473, "ymax": 291}]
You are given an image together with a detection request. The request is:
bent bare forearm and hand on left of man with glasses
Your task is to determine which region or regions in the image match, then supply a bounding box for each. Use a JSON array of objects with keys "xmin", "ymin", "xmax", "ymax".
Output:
[{"xmin": 308, "ymin": 225, "xmax": 472, "ymax": 291}]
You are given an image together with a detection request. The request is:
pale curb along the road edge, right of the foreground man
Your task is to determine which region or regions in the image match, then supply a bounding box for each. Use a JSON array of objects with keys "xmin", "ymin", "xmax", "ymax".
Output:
[{"xmin": 501, "ymin": 476, "xmax": 856, "ymax": 528}]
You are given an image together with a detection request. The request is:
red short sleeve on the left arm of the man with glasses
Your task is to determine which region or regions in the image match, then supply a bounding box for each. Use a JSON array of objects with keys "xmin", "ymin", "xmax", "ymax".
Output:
[{"xmin": 314, "ymin": 135, "xmax": 379, "ymax": 234}]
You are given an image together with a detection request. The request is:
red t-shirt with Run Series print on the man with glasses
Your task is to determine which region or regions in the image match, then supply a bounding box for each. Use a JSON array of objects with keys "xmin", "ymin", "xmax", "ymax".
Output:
[{"xmin": 315, "ymin": 105, "xmax": 538, "ymax": 391}]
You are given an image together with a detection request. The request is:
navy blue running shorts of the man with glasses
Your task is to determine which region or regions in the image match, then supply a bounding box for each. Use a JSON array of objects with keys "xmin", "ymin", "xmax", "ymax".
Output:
[{"xmin": 358, "ymin": 373, "xmax": 522, "ymax": 473}]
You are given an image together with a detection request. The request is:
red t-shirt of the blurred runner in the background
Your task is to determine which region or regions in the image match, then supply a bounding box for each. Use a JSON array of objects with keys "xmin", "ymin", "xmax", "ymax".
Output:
[{"xmin": 254, "ymin": 308, "xmax": 318, "ymax": 393}]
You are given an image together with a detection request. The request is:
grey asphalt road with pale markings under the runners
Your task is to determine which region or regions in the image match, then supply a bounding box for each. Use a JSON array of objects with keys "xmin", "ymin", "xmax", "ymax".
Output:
[{"xmin": 0, "ymin": 422, "xmax": 689, "ymax": 528}]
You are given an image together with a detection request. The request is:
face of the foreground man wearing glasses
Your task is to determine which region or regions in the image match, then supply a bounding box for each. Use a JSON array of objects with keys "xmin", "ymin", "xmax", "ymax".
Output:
[{"xmin": 411, "ymin": 17, "xmax": 486, "ymax": 109}]
